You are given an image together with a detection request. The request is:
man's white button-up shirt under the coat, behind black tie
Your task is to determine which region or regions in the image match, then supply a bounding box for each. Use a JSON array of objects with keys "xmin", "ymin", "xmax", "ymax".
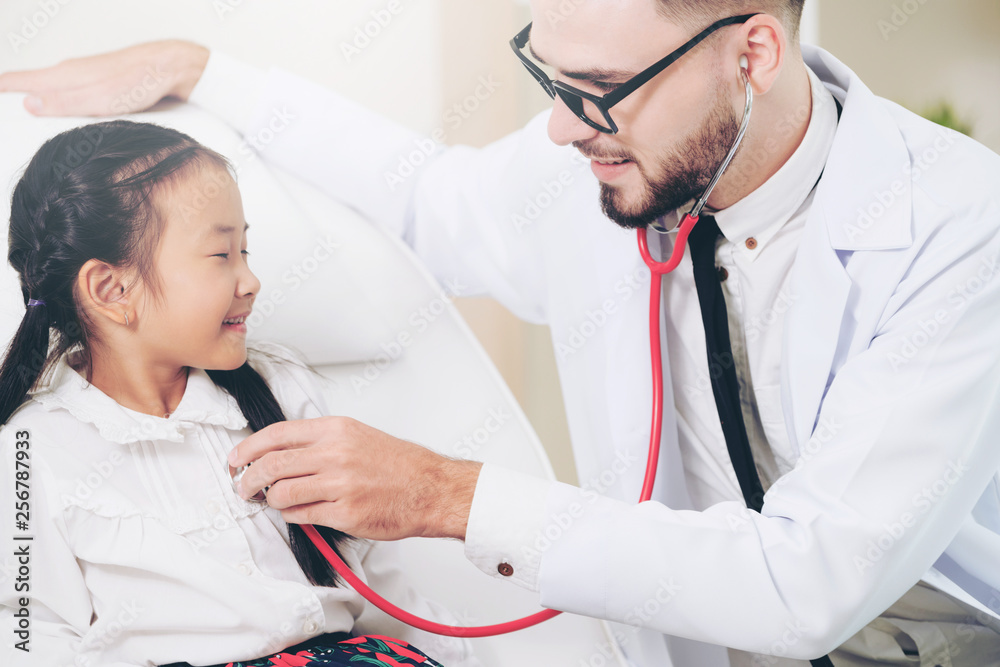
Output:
[{"xmin": 660, "ymin": 68, "xmax": 837, "ymax": 509}]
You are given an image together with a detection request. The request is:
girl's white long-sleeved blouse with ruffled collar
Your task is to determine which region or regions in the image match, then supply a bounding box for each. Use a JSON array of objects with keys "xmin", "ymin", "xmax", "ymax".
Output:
[{"xmin": 0, "ymin": 344, "xmax": 476, "ymax": 667}]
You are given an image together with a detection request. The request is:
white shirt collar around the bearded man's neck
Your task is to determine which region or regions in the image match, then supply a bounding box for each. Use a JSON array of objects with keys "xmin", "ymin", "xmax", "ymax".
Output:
[{"xmin": 712, "ymin": 67, "xmax": 837, "ymax": 261}]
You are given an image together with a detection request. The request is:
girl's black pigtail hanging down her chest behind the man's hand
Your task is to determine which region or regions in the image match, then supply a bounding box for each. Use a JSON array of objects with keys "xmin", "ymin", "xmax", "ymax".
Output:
[{"xmin": 205, "ymin": 361, "xmax": 351, "ymax": 586}]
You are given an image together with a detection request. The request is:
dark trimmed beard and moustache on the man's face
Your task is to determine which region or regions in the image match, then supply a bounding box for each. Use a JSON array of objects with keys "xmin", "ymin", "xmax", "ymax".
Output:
[{"xmin": 574, "ymin": 90, "xmax": 740, "ymax": 229}]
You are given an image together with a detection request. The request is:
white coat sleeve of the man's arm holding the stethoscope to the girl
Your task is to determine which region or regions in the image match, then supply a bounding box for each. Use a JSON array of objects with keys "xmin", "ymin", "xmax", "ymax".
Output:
[{"xmin": 467, "ymin": 198, "xmax": 1000, "ymax": 659}]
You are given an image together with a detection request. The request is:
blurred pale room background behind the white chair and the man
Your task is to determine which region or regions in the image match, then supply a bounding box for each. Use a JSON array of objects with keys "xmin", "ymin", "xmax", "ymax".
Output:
[{"xmin": 0, "ymin": 0, "xmax": 1000, "ymax": 482}]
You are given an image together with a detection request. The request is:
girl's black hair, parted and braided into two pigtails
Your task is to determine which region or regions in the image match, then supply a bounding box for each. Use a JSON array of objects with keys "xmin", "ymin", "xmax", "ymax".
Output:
[{"xmin": 0, "ymin": 120, "xmax": 349, "ymax": 586}]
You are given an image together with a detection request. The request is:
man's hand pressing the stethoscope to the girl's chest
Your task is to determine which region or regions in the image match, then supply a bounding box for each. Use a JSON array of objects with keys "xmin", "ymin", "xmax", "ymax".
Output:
[{"xmin": 229, "ymin": 417, "xmax": 482, "ymax": 540}]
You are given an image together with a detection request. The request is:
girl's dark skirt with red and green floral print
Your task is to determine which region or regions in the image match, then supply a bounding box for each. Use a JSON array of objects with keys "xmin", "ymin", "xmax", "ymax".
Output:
[{"xmin": 164, "ymin": 635, "xmax": 442, "ymax": 667}]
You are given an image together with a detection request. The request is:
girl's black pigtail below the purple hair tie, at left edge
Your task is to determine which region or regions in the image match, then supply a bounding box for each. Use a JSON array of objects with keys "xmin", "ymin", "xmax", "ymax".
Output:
[{"xmin": 0, "ymin": 299, "xmax": 49, "ymax": 424}]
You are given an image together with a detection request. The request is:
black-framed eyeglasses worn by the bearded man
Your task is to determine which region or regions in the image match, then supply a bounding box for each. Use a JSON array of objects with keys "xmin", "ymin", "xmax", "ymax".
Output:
[{"xmin": 510, "ymin": 12, "xmax": 759, "ymax": 134}]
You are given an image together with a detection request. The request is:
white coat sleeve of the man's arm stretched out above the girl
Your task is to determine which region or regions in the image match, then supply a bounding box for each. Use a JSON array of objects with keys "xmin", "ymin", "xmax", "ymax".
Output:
[{"xmin": 190, "ymin": 52, "xmax": 575, "ymax": 323}]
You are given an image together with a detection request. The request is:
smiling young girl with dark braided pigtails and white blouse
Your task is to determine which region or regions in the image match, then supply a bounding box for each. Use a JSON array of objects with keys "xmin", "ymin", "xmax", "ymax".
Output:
[{"xmin": 0, "ymin": 121, "xmax": 465, "ymax": 667}]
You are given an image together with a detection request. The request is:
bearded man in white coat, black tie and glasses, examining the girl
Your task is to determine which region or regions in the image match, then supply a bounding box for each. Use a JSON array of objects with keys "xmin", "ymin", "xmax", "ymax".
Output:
[{"xmin": 0, "ymin": 0, "xmax": 1000, "ymax": 667}]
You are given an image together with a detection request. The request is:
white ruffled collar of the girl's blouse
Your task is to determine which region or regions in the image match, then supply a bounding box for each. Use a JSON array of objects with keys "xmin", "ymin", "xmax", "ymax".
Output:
[{"xmin": 31, "ymin": 352, "xmax": 247, "ymax": 444}]
